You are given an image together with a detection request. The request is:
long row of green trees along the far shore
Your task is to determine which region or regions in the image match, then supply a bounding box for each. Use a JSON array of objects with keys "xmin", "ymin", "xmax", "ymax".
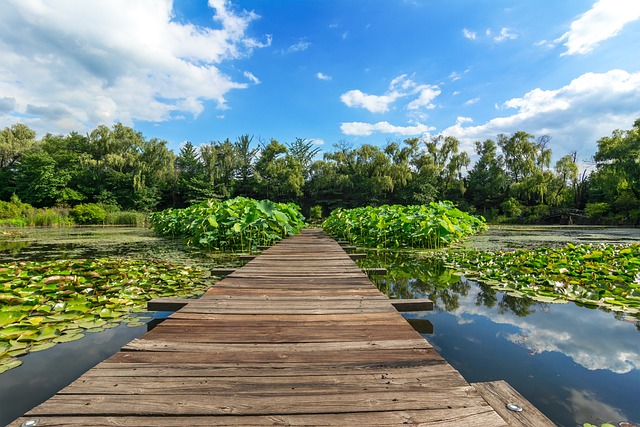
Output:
[{"xmin": 0, "ymin": 119, "xmax": 640, "ymax": 223}]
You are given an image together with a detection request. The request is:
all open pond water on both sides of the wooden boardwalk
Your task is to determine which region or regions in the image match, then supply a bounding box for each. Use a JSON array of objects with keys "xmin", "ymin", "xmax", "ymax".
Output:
[{"xmin": 0, "ymin": 227, "xmax": 640, "ymax": 427}]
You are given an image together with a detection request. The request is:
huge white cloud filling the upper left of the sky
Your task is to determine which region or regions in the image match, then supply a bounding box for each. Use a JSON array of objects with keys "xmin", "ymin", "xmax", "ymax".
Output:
[{"xmin": 0, "ymin": 0, "xmax": 271, "ymax": 133}]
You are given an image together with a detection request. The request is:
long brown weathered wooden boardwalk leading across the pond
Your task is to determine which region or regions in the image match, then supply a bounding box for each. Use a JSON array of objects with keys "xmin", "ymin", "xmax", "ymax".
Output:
[{"xmin": 11, "ymin": 230, "xmax": 552, "ymax": 427}]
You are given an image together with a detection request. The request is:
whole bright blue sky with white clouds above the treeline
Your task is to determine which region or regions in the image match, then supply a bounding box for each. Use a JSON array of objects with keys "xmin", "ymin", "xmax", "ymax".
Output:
[{"xmin": 0, "ymin": 0, "xmax": 640, "ymax": 166}]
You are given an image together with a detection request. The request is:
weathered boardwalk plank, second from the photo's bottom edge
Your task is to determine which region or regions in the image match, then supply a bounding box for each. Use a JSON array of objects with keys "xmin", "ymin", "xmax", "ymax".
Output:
[{"xmin": 26, "ymin": 386, "xmax": 488, "ymax": 417}]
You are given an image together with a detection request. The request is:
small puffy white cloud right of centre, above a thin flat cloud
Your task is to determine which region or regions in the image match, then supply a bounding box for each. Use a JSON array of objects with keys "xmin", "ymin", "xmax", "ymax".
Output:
[{"xmin": 340, "ymin": 74, "xmax": 441, "ymax": 113}]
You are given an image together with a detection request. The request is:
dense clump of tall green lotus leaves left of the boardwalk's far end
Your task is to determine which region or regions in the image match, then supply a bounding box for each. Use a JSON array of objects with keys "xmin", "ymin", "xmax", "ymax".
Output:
[{"xmin": 151, "ymin": 197, "xmax": 305, "ymax": 251}]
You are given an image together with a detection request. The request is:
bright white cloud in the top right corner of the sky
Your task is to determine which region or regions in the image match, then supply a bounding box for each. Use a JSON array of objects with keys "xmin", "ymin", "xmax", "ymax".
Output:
[{"xmin": 555, "ymin": 0, "xmax": 640, "ymax": 55}]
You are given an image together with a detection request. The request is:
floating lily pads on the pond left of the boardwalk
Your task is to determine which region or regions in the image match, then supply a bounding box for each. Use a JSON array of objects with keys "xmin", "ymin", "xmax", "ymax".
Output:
[{"xmin": 0, "ymin": 259, "xmax": 211, "ymax": 373}]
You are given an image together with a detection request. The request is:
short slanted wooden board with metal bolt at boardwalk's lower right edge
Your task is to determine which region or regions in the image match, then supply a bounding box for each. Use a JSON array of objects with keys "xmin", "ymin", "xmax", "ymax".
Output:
[{"xmin": 472, "ymin": 381, "xmax": 555, "ymax": 427}]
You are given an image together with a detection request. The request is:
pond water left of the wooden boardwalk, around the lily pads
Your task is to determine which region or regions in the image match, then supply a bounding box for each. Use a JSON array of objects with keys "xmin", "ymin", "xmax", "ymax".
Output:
[{"xmin": 0, "ymin": 227, "xmax": 239, "ymax": 425}]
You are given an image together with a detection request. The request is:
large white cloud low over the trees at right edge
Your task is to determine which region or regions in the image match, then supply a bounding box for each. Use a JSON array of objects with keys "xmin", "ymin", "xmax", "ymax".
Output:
[{"xmin": 443, "ymin": 70, "xmax": 640, "ymax": 158}]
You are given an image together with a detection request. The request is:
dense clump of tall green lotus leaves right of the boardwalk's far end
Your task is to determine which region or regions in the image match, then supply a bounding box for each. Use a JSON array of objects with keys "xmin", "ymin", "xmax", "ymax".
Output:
[{"xmin": 322, "ymin": 201, "xmax": 486, "ymax": 248}]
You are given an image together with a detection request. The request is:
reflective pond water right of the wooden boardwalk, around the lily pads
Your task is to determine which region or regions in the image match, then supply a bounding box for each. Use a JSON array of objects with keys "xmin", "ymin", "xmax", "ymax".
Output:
[{"xmin": 362, "ymin": 227, "xmax": 640, "ymax": 427}]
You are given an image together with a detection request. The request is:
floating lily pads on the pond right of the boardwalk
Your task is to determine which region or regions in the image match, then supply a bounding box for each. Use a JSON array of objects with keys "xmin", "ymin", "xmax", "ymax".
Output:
[{"xmin": 445, "ymin": 243, "xmax": 640, "ymax": 314}]
